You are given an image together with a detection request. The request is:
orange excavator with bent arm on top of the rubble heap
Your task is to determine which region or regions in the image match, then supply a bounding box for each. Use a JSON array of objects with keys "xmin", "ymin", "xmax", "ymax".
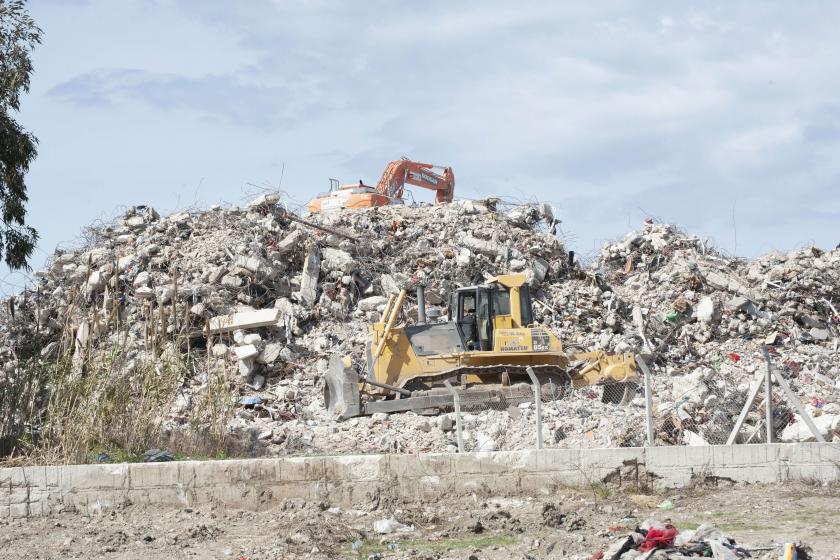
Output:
[{"xmin": 307, "ymin": 157, "xmax": 455, "ymax": 214}]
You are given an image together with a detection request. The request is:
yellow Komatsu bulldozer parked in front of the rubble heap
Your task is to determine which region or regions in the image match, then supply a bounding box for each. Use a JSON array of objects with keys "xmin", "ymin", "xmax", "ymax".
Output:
[{"xmin": 324, "ymin": 274, "xmax": 638, "ymax": 419}]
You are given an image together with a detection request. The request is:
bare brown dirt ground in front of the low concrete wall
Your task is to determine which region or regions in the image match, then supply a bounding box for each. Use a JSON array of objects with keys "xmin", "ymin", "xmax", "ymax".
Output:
[{"xmin": 0, "ymin": 484, "xmax": 840, "ymax": 560}]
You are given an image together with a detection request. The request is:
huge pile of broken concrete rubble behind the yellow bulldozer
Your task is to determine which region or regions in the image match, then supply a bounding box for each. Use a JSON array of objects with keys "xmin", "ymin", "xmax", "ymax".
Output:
[{"xmin": 0, "ymin": 199, "xmax": 840, "ymax": 454}]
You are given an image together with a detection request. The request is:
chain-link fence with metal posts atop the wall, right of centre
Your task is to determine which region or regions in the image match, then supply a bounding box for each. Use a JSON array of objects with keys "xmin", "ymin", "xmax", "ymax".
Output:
[{"xmin": 436, "ymin": 349, "xmax": 833, "ymax": 452}]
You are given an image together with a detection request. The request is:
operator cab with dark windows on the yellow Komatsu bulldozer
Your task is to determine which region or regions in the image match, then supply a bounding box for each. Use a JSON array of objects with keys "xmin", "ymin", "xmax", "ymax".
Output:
[{"xmin": 449, "ymin": 278, "xmax": 533, "ymax": 351}]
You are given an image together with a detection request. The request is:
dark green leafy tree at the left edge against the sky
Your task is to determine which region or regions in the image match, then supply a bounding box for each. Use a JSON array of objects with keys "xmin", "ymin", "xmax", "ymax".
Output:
[{"xmin": 0, "ymin": 0, "xmax": 41, "ymax": 270}]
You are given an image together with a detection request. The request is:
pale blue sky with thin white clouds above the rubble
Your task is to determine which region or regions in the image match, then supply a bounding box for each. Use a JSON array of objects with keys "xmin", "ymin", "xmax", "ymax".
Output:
[{"xmin": 0, "ymin": 0, "xmax": 840, "ymax": 292}]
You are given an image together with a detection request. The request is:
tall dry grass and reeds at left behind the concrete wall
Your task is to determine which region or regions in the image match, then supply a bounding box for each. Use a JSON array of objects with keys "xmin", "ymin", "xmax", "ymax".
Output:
[{"xmin": 0, "ymin": 332, "xmax": 239, "ymax": 464}]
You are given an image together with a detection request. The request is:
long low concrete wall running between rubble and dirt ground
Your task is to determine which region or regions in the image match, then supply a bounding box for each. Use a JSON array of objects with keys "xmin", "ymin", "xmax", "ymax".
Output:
[{"xmin": 0, "ymin": 443, "xmax": 840, "ymax": 517}]
